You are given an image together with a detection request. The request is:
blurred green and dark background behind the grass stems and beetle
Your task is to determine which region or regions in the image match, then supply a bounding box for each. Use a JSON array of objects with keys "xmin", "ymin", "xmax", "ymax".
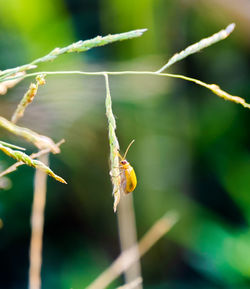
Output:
[{"xmin": 0, "ymin": 0, "xmax": 250, "ymax": 289}]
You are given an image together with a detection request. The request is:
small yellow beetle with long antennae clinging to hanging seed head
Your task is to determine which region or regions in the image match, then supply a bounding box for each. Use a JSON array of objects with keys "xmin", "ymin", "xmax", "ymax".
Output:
[{"xmin": 118, "ymin": 140, "xmax": 137, "ymax": 194}]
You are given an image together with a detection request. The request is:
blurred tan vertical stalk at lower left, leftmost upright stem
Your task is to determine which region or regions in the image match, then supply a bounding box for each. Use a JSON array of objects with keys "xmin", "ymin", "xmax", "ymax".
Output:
[{"xmin": 29, "ymin": 154, "xmax": 49, "ymax": 289}]
